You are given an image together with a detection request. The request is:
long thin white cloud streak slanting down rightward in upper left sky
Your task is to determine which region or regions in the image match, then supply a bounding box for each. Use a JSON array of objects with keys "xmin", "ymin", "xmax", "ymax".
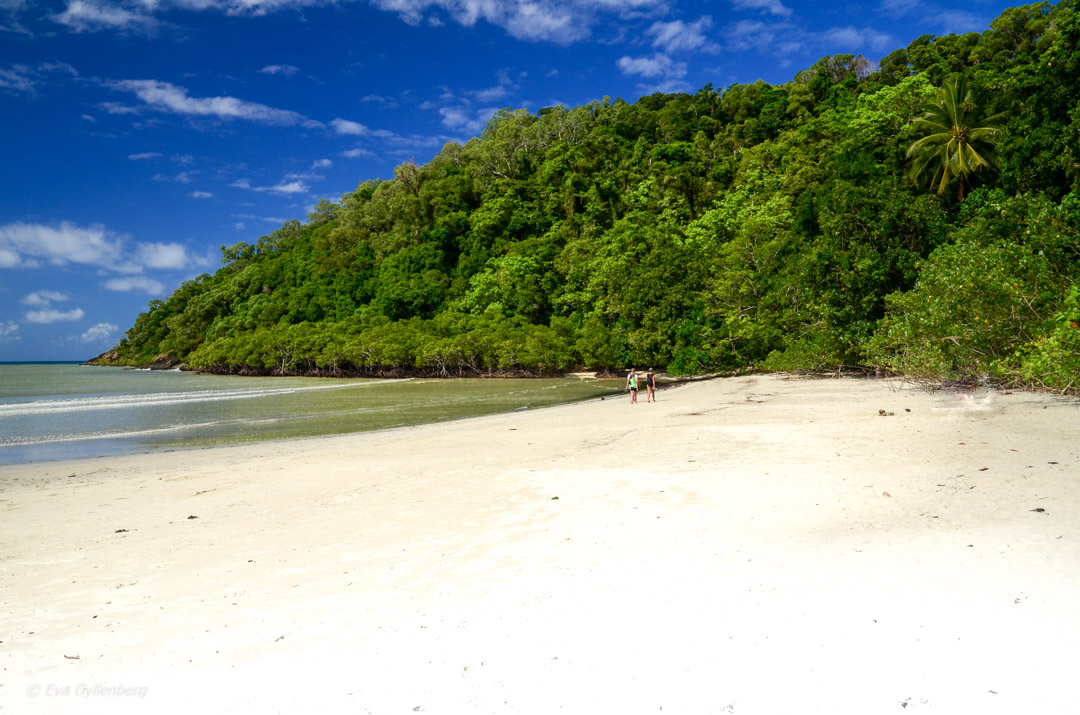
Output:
[{"xmin": 103, "ymin": 80, "xmax": 322, "ymax": 129}]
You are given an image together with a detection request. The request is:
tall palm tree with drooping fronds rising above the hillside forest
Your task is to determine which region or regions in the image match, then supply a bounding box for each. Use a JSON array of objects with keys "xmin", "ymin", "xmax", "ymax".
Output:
[{"xmin": 907, "ymin": 77, "xmax": 1005, "ymax": 201}]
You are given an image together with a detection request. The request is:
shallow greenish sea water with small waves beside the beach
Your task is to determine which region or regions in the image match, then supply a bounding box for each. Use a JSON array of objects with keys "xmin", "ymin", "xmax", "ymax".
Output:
[{"xmin": 0, "ymin": 364, "xmax": 622, "ymax": 464}]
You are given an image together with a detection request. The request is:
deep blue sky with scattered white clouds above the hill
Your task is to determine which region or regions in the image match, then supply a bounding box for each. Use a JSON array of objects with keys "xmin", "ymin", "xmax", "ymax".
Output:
[{"xmin": 0, "ymin": 0, "xmax": 1015, "ymax": 361}]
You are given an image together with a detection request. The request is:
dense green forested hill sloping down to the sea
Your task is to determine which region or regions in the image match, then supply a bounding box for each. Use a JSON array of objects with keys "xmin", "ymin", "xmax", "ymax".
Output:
[{"xmin": 96, "ymin": 0, "xmax": 1080, "ymax": 392}]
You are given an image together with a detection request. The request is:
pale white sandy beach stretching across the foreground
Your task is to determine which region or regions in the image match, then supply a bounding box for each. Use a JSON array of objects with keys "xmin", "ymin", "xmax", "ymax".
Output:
[{"xmin": 0, "ymin": 376, "xmax": 1080, "ymax": 715}]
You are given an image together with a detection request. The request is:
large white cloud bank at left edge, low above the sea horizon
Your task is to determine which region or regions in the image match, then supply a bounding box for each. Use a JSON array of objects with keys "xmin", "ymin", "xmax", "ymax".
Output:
[{"xmin": 0, "ymin": 221, "xmax": 200, "ymax": 274}]
